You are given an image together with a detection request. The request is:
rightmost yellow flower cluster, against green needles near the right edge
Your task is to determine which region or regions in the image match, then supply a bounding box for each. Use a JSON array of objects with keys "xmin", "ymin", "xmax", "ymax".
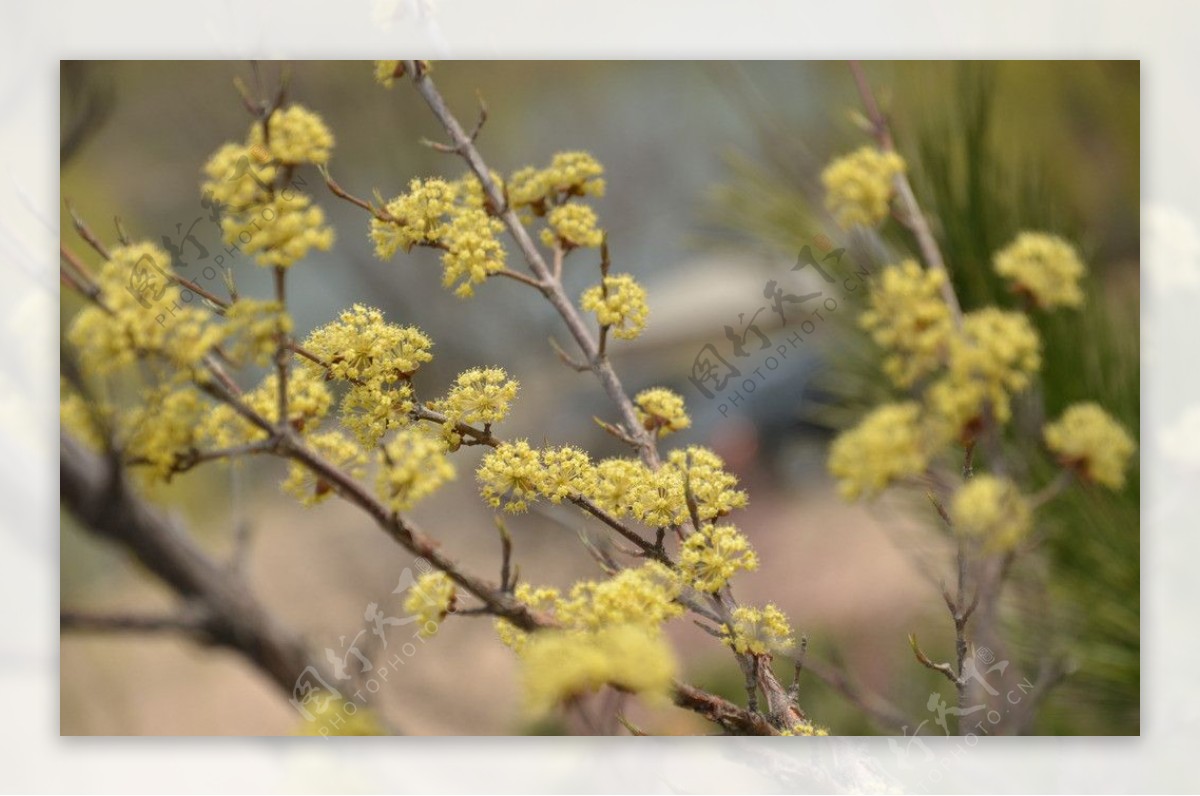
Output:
[{"xmin": 1043, "ymin": 403, "xmax": 1136, "ymax": 490}]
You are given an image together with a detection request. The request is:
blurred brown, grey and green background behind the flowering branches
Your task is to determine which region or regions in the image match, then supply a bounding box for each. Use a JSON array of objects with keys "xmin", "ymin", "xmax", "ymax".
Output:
[{"xmin": 61, "ymin": 61, "xmax": 1140, "ymax": 735}]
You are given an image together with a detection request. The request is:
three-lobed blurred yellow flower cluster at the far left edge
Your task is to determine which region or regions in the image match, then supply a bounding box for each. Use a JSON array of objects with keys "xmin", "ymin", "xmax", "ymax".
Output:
[{"xmin": 67, "ymin": 243, "xmax": 223, "ymax": 373}]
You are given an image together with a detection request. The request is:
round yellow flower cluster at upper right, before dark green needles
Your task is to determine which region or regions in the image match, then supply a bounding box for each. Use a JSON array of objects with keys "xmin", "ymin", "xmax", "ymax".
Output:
[{"xmin": 992, "ymin": 232, "xmax": 1084, "ymax": 309}]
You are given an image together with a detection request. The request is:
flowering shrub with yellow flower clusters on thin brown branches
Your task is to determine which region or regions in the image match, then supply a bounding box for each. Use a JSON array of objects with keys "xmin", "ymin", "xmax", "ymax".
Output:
[{"xmin": 62, "ymin": 61, "xmax": 1134, "ymax": 736}]
